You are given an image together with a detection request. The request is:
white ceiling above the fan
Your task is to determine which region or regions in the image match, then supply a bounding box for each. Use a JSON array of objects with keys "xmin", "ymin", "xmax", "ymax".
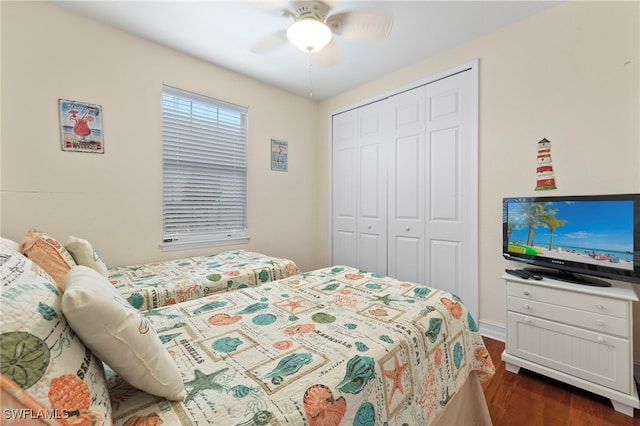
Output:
[{"xmin": 51, "ymin": 0, "xmax": 559, "ymax": 101}]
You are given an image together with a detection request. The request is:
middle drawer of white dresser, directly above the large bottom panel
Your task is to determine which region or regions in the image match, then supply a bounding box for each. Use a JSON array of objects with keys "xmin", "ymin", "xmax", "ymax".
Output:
[{"xmin": 507, "ymin": 296, "xmax": 629, "ymax": 337}]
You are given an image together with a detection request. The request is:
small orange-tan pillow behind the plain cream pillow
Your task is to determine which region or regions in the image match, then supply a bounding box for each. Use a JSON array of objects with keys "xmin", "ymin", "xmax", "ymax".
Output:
[{"xmin": 20, "ymin": 229, "xmax": 76, "ymax": 290}]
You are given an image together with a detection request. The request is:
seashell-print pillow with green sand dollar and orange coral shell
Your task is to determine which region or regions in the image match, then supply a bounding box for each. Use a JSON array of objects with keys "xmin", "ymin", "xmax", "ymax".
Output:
[{"xmin": 0, "ymin": 244, "xmax": 112, "ymax": 424}]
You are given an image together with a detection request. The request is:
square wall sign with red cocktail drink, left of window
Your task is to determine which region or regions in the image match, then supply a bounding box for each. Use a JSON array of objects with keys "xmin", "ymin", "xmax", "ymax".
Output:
[{"xmin": 58, "ymin": 99, "xmax": 104, "ymax": 154}]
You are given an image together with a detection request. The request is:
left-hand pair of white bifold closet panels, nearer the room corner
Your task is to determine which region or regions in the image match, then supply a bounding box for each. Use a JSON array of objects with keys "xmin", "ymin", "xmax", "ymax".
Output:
[{"xmin": 332, "ymin": 102, "xmax": 389, "ymax": 275}]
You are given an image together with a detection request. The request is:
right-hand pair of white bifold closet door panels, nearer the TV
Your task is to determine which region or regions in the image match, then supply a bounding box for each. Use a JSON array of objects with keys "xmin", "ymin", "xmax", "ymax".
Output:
[{"xmin": 388, "ymin": 71, "xmax": 478, "ymax": 301}]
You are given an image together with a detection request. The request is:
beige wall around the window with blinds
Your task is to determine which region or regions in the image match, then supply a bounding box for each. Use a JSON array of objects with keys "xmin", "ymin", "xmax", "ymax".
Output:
[{"xmin": 1, "ymin": 2, "xmax": 324, "ymax": 269}]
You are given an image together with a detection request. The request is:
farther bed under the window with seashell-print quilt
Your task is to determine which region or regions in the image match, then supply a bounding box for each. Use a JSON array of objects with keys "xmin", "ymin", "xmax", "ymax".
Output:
[{"xmin": 108, "ymin": 250, "xmax": 300, "ymax": 310}]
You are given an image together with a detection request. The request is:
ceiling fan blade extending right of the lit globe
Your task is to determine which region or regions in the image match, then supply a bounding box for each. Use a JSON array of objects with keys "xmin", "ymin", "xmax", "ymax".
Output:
[{"xmin": 327, "ymin": 10, "xmax": 393, "ymax": 40}]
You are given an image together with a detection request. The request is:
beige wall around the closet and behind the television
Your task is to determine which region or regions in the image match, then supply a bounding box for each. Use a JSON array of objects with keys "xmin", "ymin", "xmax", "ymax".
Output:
[{"xmin": 318, "ymin": 1, "xmax": 640, "ymax": 341}]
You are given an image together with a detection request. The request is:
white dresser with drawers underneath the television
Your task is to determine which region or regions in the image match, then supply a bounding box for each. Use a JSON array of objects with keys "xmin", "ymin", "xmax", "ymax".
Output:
[{"xmin": 502, "ymin": 275, "xmax": 640, "ymax": 416}]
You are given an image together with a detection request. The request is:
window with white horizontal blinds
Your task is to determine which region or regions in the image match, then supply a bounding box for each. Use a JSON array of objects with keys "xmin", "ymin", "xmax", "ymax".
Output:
[{"xmin": 162, "ymin": 86, "xmax": 249, "ymax": 250}]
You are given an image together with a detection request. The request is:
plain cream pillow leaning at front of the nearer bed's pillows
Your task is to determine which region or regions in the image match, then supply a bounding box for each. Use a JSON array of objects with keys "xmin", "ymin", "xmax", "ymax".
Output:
[{"xmin": 62, "ymin": 266, "xmax": 186, "ymax": 401}]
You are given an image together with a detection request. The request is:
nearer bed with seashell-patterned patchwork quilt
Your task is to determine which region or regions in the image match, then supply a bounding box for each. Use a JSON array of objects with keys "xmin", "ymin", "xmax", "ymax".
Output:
[{"xmin": 106, "ymin": 266, "xmax": 494, "ymax": 426}]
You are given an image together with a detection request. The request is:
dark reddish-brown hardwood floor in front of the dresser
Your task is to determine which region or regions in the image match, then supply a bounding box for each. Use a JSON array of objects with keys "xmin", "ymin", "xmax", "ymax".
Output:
[{"xmin": 482, "ymin": 337, "xmax": 640, "ymax": 426}]
